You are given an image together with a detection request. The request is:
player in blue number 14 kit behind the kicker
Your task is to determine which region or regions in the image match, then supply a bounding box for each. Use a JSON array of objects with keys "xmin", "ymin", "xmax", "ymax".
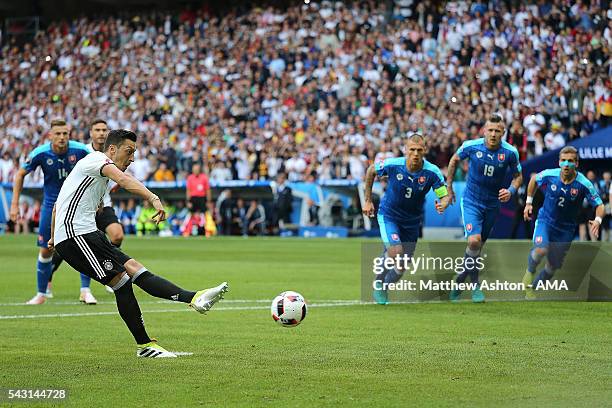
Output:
[{"xmin": 10, "ymin": 120, "xmax": 97, "ymax": 305}]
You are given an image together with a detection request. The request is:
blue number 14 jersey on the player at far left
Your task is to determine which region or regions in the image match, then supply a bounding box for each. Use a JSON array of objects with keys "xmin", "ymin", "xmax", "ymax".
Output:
[{"xmin": 23, "ymin": 140, "xmax": 90, "ymax": 207}]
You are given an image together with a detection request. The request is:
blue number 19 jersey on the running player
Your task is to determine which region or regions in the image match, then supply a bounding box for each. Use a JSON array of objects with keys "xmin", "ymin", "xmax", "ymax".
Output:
[{"xmin": 457, "ymin": 138, "xmax": 521, "ymax": 208}]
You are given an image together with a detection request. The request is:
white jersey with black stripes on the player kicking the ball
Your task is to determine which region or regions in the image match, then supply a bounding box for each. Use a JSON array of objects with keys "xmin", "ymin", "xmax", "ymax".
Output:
[{"xmin": 54, "ymin": 152, "xmax": 114, "ymax": 244}]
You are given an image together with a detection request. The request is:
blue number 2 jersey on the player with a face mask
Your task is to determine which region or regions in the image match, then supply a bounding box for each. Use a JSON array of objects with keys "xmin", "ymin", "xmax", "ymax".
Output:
[{"xmin": 536, "ymin": 169, "xmax": 603, "ymax": 230}]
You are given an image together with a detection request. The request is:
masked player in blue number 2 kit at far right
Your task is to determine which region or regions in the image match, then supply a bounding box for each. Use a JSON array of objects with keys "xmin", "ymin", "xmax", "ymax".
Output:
[{"xmin": 523, "ymin": 146, "xmax": 605, "ymax": 299}]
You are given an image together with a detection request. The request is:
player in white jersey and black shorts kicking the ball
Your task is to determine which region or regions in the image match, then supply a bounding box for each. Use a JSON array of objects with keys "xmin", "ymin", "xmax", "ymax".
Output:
[{"xmin": 49, "ymin": 129, "xmax": 228, "ymax": 358}]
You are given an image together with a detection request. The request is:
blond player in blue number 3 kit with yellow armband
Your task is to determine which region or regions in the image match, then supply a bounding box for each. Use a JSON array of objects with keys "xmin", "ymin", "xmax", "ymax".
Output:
[{"xmin": 363, "ymin": 134, "xmax": 449, "ymax": 305}]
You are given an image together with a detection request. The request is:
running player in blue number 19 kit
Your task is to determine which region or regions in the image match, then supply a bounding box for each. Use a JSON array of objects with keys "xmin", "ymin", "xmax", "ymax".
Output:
[{"xmin": 446, "ymin": 114, "xmax": 523, "ymax": 303}]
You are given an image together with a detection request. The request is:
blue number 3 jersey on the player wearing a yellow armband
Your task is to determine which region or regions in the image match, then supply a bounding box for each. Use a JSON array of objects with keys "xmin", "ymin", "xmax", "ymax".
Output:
[{"xmin": 376, "ymin": 157, "xmax": 445, "ymax": 225}]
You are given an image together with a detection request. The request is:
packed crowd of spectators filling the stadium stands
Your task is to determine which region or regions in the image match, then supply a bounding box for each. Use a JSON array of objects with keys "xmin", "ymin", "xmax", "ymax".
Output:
[{"xmin": 0, "ymin": 0, "xmax": 612, "ymax": 186}]
